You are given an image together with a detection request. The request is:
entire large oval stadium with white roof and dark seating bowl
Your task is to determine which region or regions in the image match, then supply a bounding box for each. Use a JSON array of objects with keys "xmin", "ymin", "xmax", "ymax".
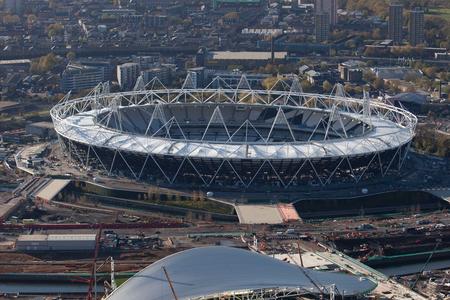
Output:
[{"xmin": 51, "ymin": 75, "xmax": 417, "ymax": 191}]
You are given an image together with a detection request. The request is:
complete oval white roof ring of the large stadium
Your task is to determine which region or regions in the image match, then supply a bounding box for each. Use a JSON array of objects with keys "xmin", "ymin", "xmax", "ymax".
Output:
[{"xmin": 51, "ymin": 83, "xmax": 417, "ymax": 160}]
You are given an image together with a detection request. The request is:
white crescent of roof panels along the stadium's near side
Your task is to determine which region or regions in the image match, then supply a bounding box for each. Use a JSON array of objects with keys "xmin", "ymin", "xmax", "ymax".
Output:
[{"xmin": 60, "ymin": 110, "xmax": 412, "ymax": 159}]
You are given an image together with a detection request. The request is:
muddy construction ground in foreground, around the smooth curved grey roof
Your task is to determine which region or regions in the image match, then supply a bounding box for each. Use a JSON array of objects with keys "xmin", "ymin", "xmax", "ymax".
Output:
[{"xmin": 0, "ymin": 124, "xmax": 450, "ymax": 299}]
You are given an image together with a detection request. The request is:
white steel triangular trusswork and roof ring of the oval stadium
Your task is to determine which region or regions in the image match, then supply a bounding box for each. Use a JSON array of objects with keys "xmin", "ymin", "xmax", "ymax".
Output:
[{"xmin": 51, "ymin": 73, "xmax": 417, "ymax": 187}]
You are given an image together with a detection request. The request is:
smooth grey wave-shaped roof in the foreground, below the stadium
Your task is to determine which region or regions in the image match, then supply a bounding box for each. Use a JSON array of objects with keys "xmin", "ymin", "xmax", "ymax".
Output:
[{"xmin": 107, "ymin": 247, "xmax": 376, "ymax": 300}]
